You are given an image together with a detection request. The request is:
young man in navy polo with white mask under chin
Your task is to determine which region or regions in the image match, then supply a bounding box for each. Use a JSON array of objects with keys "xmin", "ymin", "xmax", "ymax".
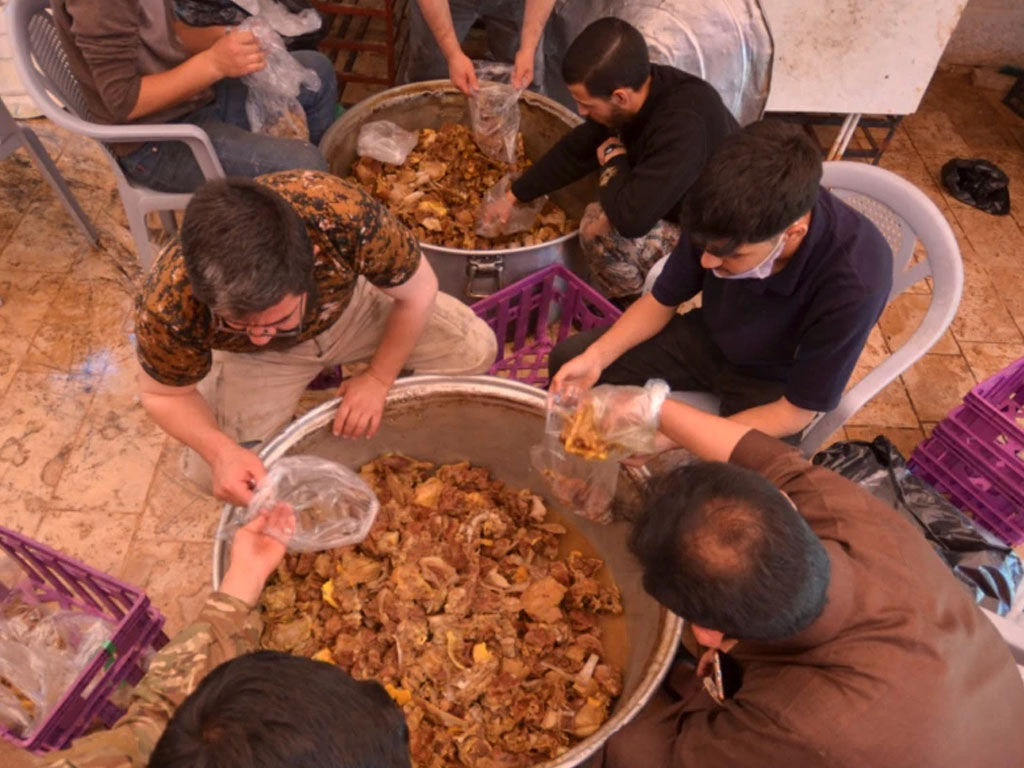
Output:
[{"xmin": 549, "ymin": 121, "xmax": 893, "ymax": 437}]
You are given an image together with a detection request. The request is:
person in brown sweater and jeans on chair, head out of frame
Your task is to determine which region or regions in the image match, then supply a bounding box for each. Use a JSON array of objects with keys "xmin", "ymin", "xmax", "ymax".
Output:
[{"xmin": 53, "ymin": 0, "xmax": 338, "ymax": 193}]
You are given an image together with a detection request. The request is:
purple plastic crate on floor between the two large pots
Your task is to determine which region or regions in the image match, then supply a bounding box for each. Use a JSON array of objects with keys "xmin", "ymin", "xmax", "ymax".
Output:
[{"xmin": 472, "ymin": 264, "xmax": 622, "ymax": 387}]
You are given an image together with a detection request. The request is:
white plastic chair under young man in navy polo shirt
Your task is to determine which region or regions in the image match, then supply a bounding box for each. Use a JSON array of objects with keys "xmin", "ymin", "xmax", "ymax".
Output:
[{"xmin": 655, "ymin": 160, "xmax": 964, "ymax": 457}]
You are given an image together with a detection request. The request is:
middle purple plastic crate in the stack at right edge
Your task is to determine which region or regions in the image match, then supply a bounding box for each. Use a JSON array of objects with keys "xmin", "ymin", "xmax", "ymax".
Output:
[{"xmin": 934, "ymin": 406, "xmax": 1024, "ymax": 495}]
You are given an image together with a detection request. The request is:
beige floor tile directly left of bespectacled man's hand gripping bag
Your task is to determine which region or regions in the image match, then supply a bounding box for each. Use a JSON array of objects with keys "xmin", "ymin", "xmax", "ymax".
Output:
[{"xmin": 139, "ymin": 438, "xmax": 222, "ymax": 542}]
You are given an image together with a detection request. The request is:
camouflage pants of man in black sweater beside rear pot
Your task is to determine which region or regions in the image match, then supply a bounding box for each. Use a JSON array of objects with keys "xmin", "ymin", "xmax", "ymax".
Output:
[{"xmin": 580, "ymin": 203, "xmax": 680, "ymax": 299}]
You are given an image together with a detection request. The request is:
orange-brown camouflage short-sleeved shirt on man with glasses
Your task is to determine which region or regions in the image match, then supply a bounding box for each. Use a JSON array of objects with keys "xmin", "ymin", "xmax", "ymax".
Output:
[{"xmin": 135, "ymin": 171, "xmax": 420, "ymax": 387}]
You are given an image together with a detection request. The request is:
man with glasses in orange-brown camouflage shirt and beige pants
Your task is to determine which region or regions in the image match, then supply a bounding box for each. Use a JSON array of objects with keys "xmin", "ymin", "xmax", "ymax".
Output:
[{"xmin": 135, "ymin": 171, "xmax": 498, "ymax": 504}]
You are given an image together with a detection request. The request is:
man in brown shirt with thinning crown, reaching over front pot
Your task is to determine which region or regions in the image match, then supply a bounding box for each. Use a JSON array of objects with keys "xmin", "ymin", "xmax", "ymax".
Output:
[{"xmin": 586, "ymin": 387, "xmax": 1024, "ymax": 768}]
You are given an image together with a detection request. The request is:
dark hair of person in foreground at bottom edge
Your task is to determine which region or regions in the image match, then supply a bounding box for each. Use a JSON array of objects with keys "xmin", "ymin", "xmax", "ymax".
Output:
[{"xmin": 148, "ymin": 650, "xmax": 410, "ymax": 768}]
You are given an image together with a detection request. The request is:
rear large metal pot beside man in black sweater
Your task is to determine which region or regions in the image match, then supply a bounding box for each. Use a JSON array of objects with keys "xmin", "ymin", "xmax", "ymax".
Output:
[{"xmin": 321, "ymin": 80, "xmax": 597, "ymax": 303}]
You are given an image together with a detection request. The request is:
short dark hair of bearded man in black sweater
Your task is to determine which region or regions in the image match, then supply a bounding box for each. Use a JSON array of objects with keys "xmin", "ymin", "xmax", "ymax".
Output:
[{"xmin": 562, "ymin": 16, "xmax": 650, "ymax": 98}]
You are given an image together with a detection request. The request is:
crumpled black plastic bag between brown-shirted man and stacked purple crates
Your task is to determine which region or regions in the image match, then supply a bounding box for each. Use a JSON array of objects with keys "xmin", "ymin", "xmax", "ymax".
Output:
[{"xmin": 811, "ymin": 436, "xmax": 1024, "ymax": 615}]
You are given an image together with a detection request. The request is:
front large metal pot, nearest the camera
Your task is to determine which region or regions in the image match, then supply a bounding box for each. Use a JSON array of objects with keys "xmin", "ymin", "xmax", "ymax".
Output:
[{"xmin": 213, "ymin": 376, "xmax": 682, "ymax": 768}]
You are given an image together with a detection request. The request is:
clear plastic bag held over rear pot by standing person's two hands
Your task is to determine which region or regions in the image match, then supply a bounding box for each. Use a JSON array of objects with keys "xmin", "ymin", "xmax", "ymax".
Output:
[{"xmin": 469, "ymin": 61, "xmax": 522, "ymax": 165}]
